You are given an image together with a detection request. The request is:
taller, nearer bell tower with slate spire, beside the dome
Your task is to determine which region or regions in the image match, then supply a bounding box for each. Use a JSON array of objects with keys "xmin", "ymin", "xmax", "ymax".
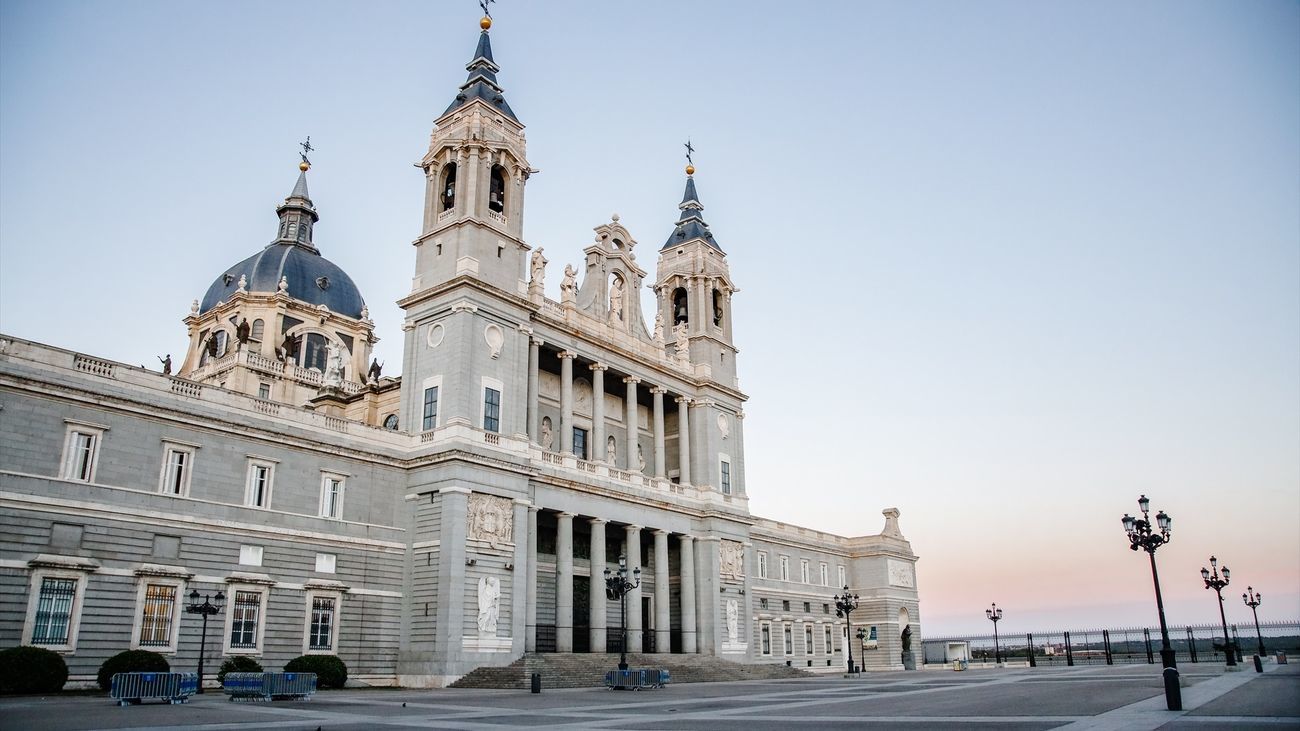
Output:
[{"xmin": 411, "ymin": 17, "xmax": 537, "ymax": 294}]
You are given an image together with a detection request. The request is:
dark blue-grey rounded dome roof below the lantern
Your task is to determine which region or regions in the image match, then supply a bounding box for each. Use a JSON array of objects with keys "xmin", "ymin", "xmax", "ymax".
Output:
[{"xmin": 200, "ymin": 243, "xmax": 365, "ymax": 319}]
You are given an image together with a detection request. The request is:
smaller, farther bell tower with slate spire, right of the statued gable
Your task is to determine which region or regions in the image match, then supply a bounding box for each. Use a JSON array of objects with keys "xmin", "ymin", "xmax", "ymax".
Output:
[{"xmin": 654, "ymin": 159, "xmax": 740, "ymax": 388}]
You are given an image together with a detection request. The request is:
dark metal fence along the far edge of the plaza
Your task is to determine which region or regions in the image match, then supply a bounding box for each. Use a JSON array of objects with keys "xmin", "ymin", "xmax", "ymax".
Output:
[{"xmin": 922, "ymin": 622, "xmax": 1300, "ymax": 667}]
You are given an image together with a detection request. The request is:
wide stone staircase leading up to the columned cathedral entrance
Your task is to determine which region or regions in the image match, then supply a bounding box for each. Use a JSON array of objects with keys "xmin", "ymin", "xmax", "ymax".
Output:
[{"xmin": 451, "ymin": 653, "xmax": 813, "ymax": 689}]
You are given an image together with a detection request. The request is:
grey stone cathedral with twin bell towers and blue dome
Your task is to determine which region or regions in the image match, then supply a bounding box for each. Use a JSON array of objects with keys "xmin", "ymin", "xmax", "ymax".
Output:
[{"xmin": 0, "ymin": 17, "xmax": 920, "ymax": 687}]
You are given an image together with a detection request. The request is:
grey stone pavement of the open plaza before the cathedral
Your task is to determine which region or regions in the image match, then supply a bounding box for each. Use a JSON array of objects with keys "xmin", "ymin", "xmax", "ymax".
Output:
[{"xmin": 0, "ymin": 663, "xmax": 1300, "ymax": 731}]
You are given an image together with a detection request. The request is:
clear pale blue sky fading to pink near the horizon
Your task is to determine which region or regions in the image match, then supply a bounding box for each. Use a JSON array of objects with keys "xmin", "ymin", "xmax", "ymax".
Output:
[{"xmin": 0, "ymin": 0, "xmax": 1300, "ymax": 636}]
